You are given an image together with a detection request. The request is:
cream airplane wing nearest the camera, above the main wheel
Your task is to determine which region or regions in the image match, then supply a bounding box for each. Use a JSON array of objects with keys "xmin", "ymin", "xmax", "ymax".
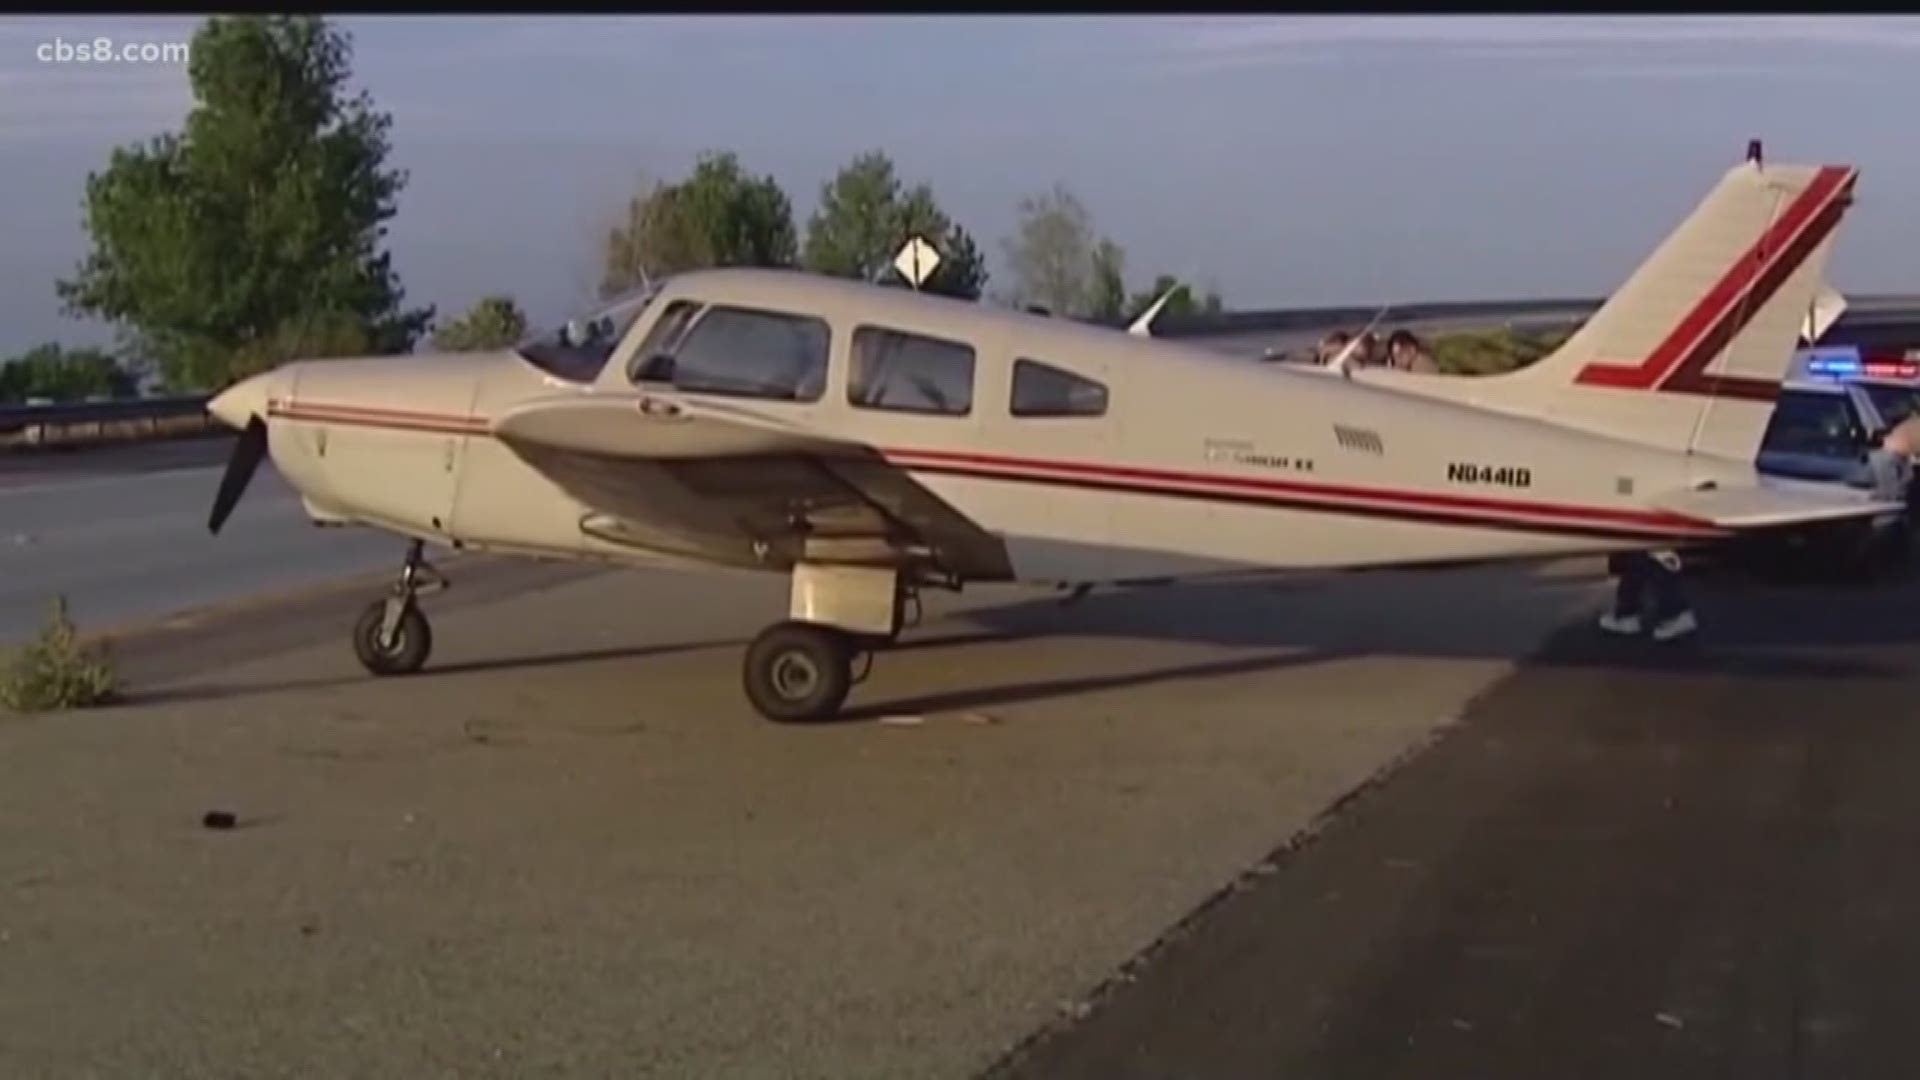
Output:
[{"xmin": 492, "ymin": 384, "xmax": 1012, "ymax": 580}]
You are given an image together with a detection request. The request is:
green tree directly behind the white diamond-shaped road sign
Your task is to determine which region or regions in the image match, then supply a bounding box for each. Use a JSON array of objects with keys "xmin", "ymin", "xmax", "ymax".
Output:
[{"xmin": 803, "ymin": 150, "xmax": 987, "ymax": 300}]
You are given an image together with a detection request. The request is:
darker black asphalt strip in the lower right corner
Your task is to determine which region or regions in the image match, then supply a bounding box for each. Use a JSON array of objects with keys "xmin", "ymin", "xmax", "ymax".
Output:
[{"xmin": 993, "ymin": 564, "xmax": 1920, "ymax": 1080}]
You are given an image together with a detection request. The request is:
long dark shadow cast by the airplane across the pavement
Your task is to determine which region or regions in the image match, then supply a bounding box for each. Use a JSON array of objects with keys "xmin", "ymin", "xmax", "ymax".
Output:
[{"xmin": 108, "ymin": 553, "xmax": 1920, "ymax": 721}]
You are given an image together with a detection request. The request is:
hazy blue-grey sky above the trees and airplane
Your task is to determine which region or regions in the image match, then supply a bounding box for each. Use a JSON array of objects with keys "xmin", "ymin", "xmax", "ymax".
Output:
[{"xmin": 0, "ymin": 15, "xmax": 1920, "ymax": 356}]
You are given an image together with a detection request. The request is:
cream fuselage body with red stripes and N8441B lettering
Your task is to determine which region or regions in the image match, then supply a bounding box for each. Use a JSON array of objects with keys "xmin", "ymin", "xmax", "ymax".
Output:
[{"xmin": 247, "ymin": 327, "xmax": 1751, "ymax": 580}]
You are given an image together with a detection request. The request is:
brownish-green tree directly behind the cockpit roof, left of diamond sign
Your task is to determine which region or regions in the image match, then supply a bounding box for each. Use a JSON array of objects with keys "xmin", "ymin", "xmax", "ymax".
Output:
[{"xmin": 601, "ymin": 152, "xmax": 799, "ymax": 296}]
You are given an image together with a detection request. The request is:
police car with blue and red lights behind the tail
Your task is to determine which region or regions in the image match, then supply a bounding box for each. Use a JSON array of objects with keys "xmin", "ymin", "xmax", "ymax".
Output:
[{"xmin": 1755, "ymin": 348, "xmax": 1920, "ymax": 565}]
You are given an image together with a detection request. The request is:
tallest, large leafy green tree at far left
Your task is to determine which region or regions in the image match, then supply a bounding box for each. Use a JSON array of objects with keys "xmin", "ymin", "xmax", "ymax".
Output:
[{"xmin": 58, "ymin": 15, "xmax": 432, "ymax": 388}]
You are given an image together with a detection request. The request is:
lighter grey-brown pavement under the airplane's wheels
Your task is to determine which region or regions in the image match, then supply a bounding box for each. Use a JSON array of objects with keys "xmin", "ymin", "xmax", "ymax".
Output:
[{"xmin": 0, "ymin": 557, "xmax": 1599, "ymax": 1080}]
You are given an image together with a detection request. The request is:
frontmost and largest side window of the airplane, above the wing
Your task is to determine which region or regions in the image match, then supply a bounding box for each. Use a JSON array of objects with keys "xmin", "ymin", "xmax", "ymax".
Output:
[{"xmin": 666, "ymin": 306, "xmax": 831, "ymax": 402}]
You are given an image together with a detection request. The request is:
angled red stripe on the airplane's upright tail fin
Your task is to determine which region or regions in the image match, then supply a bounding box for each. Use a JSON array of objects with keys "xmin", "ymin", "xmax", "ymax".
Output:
[{"xmin": 1574, "ymin": 165, "xmax": 1859, "ymax": 400}]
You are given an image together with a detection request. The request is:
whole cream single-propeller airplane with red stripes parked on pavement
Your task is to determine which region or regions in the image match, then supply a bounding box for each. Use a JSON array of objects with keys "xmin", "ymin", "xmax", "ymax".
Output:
[{"xmin": 209, "ymin": 141, "xmax": 1899, "ymax": 721}]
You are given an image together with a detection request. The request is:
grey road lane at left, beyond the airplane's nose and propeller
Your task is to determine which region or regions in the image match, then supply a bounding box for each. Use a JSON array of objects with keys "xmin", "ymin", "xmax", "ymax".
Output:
[{"xmin": 0, "ymin": 438, "xmax": 403, "ymax": 644}]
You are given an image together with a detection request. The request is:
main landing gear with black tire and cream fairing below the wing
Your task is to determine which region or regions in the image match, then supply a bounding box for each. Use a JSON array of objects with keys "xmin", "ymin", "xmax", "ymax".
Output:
[{"xmin": 741, "ymin": 563, "xmax": 920, "ymax": 723}]
